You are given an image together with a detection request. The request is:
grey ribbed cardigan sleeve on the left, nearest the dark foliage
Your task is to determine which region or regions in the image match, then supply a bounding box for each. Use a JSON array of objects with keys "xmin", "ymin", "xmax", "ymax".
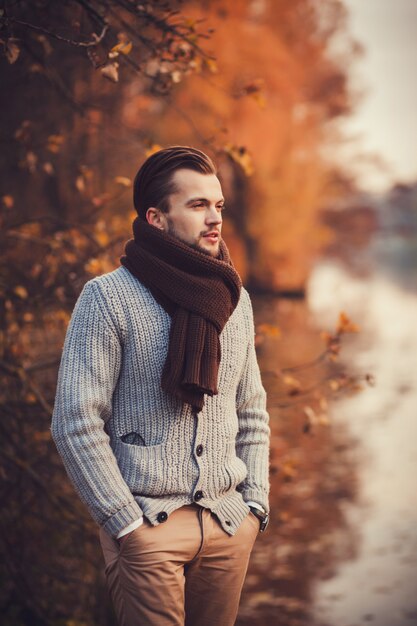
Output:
[{"xmin": 51, "ymin": 279, "xmax": 142, "ymax": 537}]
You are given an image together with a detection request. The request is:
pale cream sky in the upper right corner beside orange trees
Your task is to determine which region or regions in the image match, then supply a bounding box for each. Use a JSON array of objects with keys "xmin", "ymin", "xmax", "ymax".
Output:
[{"xmin": 340, "ymin": 0, "xmax": 417, "ymax": 192}]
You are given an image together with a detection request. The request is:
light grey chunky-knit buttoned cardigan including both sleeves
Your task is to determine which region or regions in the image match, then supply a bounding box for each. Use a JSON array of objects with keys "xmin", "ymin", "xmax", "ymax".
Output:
[{"xmin": 51, "ymin": 266, "xmax": 270, "ymax": 537}]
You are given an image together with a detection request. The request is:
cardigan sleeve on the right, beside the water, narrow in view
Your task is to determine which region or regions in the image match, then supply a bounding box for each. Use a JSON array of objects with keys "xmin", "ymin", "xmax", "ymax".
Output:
[{"xmin": 236, "ymin": 292, "xmax": 270, "ymax": 511}]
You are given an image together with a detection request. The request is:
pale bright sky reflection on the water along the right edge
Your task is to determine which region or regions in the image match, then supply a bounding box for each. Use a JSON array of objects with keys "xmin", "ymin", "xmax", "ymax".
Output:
[{"xmin": 309, "ymin": 264, "xmax": 417, "ymax": 626}]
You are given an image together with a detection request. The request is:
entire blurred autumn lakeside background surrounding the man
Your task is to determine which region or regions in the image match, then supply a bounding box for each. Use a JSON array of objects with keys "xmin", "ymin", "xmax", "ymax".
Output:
[{"xmin": 0, "ymin": 0, "xmax": 417, "ymax": 626}]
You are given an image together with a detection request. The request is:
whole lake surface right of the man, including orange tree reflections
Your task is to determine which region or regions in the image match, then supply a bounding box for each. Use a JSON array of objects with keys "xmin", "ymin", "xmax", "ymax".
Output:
[{"xmin": 237, "ymin": 222, "xmax": 417, "ymax": 626}]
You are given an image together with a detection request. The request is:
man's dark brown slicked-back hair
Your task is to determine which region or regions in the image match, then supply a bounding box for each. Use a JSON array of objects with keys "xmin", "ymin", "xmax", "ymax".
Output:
[{"xmin": 133, "ymin": 146, "xmax": 217, "ymax": 220}]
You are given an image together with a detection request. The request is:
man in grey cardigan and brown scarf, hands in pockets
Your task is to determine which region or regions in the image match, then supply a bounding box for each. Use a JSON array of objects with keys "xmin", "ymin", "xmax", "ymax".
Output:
[{"xmin": 52, "ymin": 146, "xmax": 270, "ymax": 626}]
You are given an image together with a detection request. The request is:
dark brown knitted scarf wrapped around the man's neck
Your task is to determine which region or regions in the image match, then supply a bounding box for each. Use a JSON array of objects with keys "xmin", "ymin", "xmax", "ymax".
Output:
[{"xmin": 120, "ymin": 217, "xmax": 242, "ymax": 412}]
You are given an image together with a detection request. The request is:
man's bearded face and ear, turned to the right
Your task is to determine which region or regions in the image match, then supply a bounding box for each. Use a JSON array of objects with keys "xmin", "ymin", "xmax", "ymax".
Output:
[{"xmin": 147, "ymin": 169, "xmax": 224, "ymax": 257}]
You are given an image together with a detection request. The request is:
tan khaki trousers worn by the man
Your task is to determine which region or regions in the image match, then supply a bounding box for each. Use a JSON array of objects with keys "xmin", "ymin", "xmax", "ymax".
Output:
[{"xmin": 100, "ymin": 504, "xmax": 259, "ymax": 626}]
